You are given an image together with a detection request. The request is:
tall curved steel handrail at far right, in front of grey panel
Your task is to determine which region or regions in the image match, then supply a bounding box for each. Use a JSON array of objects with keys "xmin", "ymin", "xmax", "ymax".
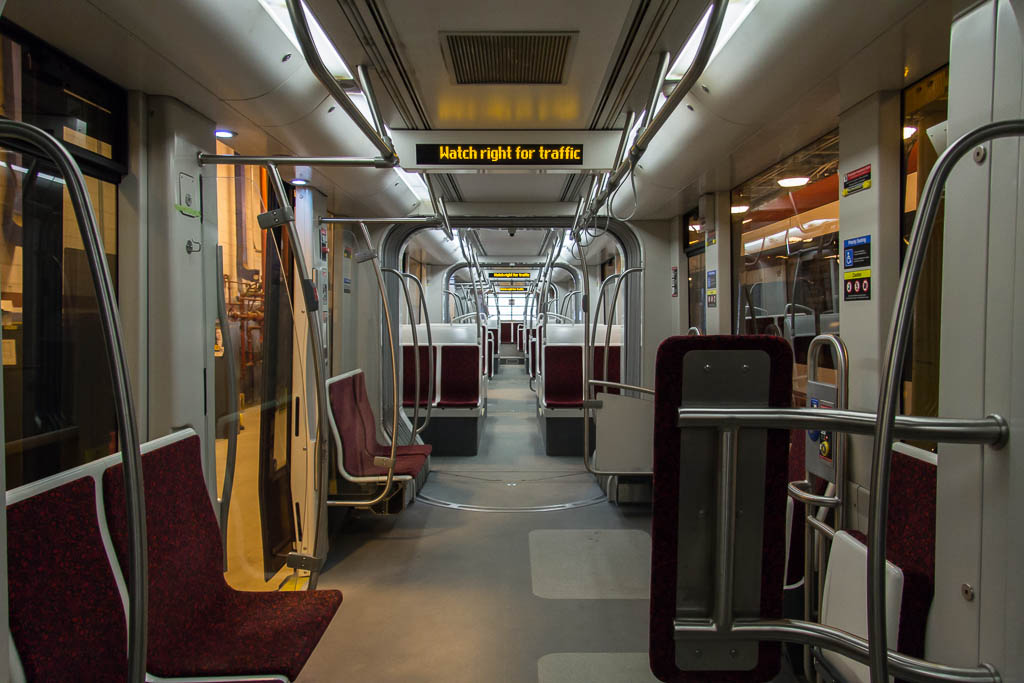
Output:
[{"xmin": 867, "ymin": 119, "xmax": 1024, "ymax": 683}]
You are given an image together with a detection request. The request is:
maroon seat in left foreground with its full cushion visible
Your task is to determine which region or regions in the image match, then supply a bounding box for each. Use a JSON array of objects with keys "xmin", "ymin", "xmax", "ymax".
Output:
[{"xmin": 103, "ymin": 436, "xmax": 341, "ymax": 680}]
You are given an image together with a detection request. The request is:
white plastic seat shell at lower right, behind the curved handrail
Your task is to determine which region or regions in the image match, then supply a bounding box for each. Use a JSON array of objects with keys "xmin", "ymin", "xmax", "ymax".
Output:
[{"xmin": 821, "ymin": 531, "xmax": 903, "ymax": 683}]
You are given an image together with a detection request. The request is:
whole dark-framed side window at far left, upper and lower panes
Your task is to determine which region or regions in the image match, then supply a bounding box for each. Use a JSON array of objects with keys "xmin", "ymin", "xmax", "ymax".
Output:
[{"xmin": 0, "ymin": 22, "xmax": 126, "ymax": 488}]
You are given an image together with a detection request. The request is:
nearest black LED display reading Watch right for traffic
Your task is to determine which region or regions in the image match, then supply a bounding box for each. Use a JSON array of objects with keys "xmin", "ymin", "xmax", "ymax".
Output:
[{"xmin": 416, "ymin": 142, "xmax": 583, "ymax": 166}]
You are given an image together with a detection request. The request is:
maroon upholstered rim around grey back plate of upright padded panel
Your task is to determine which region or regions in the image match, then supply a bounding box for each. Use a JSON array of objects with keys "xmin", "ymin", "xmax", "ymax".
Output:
[{"xmin": 650, "ymin": 336, "xmax": 793, "ymax": 683}]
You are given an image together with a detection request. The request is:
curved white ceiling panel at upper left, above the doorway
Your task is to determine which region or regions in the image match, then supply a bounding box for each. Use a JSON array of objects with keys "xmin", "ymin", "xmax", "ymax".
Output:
[{"xmin": 5, "ymin": 0, "xmax": 419, "ymax": 215}]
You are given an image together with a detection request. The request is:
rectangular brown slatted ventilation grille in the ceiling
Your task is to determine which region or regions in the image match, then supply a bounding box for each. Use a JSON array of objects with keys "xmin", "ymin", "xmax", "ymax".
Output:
[{"xmin": 441, "ymin": 32, "xmax": 574, "ymax": 85}]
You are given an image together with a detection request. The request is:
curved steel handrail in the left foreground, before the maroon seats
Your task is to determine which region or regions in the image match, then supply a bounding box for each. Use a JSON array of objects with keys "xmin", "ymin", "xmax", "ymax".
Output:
[{"xmin": 0, "ymin": 119, "xmax": 150, "ymax": 683}]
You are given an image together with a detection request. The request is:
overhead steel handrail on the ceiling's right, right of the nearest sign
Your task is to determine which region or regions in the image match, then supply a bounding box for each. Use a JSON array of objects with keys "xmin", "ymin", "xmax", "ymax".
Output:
[{"xmin": 585, "ymin": 0, "xmax": 729, "ymax": 225}]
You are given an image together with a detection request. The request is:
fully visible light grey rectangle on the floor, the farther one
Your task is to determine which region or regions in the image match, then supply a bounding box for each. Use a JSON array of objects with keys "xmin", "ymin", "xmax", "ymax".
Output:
[{"xmin": 529, "ymin": 529, "xmax": 650, "ymax": 600}]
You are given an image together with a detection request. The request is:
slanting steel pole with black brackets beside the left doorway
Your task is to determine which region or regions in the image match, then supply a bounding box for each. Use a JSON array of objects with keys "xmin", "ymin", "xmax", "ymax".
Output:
[{"xmin": 266, "ymin": 164, "xmax": 329, "ymax": 590}]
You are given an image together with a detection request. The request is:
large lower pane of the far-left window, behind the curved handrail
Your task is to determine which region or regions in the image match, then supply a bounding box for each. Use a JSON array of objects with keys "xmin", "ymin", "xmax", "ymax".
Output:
[{"xmin": 0, "ymin": 151, "xmax": 118, "ymax": 488}]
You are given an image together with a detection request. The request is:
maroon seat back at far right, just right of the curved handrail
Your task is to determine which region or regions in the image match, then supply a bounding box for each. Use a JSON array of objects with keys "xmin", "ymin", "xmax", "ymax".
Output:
[{"xmin": 850, "ymin": 453, "xmax": 936, "ymax": 671}]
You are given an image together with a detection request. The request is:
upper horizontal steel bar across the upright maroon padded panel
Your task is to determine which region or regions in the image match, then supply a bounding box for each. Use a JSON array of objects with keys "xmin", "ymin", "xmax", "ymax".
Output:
[{"xmin": 679, "ymin": 408, "xmax": 1010, "ymax": 449}]
